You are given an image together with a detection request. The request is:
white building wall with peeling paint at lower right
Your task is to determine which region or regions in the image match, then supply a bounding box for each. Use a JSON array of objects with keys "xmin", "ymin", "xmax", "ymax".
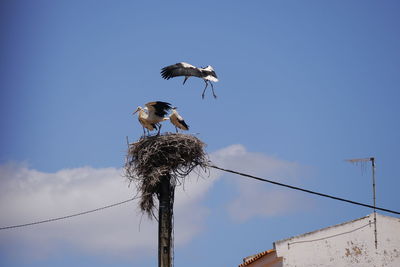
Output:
[{"xmin": 275, "ymin": 214, "xmax": 400, "ymax": 267}]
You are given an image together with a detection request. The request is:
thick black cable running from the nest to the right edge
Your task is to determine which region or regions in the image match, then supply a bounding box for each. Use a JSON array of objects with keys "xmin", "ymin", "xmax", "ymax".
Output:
[{"xmin": 209, "ymin": 165, "xmax": 400, "ymax": 217}]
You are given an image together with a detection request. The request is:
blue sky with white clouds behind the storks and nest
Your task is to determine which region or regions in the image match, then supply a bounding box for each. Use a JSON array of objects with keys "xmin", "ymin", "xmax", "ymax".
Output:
[{"xmin": 0, "ymin": 0, "xmax": 400, "ymax": 266}]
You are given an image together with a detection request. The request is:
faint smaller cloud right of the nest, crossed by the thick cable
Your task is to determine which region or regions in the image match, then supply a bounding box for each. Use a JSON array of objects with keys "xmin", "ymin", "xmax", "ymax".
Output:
[{"xmin": 212, "ymin": 145, "xmax": 310, "ymax": 222}]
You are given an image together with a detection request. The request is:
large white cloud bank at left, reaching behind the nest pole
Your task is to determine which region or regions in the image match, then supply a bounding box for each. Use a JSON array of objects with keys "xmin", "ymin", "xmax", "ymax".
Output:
[{"xmin": 0, "ymin": 161, "xmax": 216, "ymax": 262}]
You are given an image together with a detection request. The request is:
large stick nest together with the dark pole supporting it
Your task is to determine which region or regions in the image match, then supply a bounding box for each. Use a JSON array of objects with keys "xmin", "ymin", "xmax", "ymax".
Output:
[{"xmin": 125, "ymin": 134, "xmax": 209, "ymax": 267}]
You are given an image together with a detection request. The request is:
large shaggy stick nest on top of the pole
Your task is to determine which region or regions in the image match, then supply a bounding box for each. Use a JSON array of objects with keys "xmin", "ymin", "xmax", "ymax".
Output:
[{"xmin": 125, "ymin": 133, "xmax": 208, "ymax": 218}]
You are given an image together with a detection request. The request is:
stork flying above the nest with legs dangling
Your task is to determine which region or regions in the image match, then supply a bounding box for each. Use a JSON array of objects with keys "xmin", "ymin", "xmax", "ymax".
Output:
[{"xmin": 161, "ymin": 62, "xmax": 218, "ymax": 99}]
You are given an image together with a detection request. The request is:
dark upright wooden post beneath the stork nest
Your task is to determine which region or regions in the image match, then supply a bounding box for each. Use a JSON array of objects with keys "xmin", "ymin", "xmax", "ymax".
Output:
[{"xmin": 158, "ymin": 174, "xmax": 174, "ymax": 267}]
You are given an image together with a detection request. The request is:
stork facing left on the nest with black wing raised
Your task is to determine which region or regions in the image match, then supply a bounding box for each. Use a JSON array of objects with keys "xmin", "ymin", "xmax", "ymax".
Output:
[{"xmin": 133, "ymin": 101, "xmax": 171, "ymax": 135}]
